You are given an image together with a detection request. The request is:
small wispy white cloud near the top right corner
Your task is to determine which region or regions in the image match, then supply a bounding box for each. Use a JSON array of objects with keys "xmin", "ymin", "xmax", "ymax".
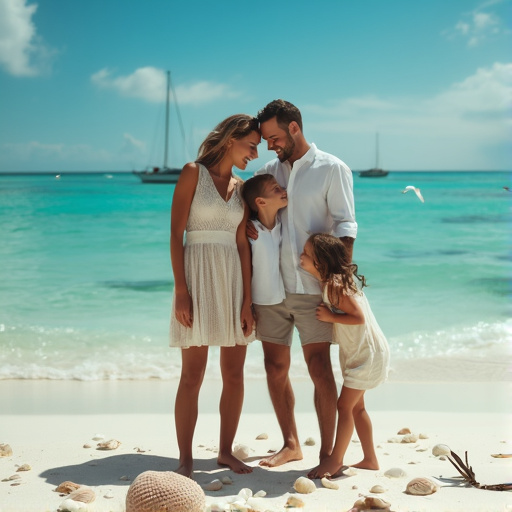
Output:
[{"xmin": 444, "ymin": 0, "xmax": 506, "ymax": 46}]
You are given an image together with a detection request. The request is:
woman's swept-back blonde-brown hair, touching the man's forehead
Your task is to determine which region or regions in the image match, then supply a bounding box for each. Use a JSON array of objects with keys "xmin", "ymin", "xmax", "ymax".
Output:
[{"xmin": 196, "ymin": 114, "xmax": 260, "ymax": 169}]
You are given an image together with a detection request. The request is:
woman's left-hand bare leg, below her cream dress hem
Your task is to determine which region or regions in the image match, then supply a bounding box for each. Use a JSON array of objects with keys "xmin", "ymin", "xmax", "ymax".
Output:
[{"xmin": 174, "ymin": 347, "xmax": 208, "ymax": 478}]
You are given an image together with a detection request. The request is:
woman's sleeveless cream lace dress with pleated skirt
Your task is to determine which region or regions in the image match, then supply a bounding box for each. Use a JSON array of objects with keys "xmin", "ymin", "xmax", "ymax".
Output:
[{"xmin": 170, "ymin": 164, "xmax": 254, "ymax": 347}]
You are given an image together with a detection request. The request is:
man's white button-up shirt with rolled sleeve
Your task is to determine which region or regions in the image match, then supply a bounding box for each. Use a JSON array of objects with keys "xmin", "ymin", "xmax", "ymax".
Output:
[{"xmin": 256, "ymin": 144, "xmax": 357, "ymax": 294}]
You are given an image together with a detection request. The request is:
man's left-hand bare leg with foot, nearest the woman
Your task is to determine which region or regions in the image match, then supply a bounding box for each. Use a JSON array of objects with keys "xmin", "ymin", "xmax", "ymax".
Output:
[{"xmin": 260, "ymin": 341, "xmax": 302, "ymax": 467}]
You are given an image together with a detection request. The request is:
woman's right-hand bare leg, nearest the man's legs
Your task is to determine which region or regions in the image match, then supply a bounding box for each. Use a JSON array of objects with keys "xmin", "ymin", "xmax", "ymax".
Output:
[{"xmin": 217, "ymin": 345, "xmax": 252, "ymax": 474}]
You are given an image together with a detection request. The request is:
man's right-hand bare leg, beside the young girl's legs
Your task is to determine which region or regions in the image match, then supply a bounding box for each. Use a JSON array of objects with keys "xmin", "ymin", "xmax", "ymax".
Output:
[{"xmin": 302, "ymin": 342, "xmax": 338, "ymax": 462}]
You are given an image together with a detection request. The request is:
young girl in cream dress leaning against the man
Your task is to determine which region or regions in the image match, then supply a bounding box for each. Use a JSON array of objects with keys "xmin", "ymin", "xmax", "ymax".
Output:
[{"xmin": 300, "ymin": 233, "xmax": 389, "ymax": 478}]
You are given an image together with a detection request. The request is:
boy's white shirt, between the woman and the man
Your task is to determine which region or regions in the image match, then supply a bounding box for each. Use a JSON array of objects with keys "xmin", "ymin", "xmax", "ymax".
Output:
[{"xmin": 249, "ymin": 218, "xmax": 285, "ymax": 306}]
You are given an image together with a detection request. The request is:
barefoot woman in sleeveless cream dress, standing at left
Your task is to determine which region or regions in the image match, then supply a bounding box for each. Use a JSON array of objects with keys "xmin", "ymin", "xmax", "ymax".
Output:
[{"xmin": 170, "ymin": 114, "xmax": 261, "ymax": 477}]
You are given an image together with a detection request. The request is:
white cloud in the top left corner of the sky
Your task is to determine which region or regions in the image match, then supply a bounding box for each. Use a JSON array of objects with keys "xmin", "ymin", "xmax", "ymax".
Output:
[{"xmin": 0, "ymin": 0, "xmax": 54, "ymax": 76}]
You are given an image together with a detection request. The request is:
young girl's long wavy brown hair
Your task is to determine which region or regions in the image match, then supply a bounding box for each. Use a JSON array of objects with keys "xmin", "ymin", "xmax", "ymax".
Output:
[{"xmin": 308, "ymin": 233, "xmax": 367, "ymax": 305}]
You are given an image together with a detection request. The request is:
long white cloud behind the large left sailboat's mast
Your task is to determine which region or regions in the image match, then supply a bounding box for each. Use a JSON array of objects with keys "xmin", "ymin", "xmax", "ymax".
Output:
[{"xmin": 91, "ymin": 66, "xmax": 238, "ymax": 105}]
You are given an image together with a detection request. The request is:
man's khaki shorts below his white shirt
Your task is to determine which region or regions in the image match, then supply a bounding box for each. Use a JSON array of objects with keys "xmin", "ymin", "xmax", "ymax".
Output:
[{"xmin": 254, "ymin": 293, "xmax": 332, "ymax": 346}]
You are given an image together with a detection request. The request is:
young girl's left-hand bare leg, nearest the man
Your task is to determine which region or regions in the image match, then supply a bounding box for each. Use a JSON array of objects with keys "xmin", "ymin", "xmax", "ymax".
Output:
[{"xmin": 308, "ymin": 386, "xmax": 364, "ymax": 478}]
